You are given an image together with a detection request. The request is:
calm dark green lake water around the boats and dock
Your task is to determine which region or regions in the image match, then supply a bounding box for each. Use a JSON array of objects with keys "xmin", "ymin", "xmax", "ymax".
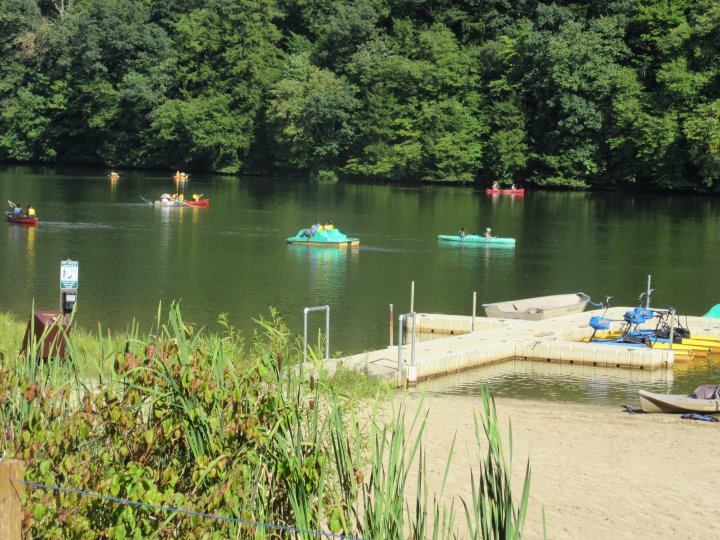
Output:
[{"xmin": 0, "ymin": 166, "xmax": 720, "ymax": 402}]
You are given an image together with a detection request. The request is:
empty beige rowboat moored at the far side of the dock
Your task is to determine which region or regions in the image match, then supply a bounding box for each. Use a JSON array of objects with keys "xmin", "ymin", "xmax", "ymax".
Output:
[{"xmin": 483, "ymin": 292, "xmax": 590, "ymax": 321}]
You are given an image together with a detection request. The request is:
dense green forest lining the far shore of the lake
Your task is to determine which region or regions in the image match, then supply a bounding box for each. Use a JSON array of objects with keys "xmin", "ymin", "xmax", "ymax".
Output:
[{"xmin": 0, "ymin": 0, "xmax": 720, "ymax": 191}]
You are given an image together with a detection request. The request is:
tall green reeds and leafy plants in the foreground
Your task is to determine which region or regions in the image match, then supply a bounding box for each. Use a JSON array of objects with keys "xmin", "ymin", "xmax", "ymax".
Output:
[{"xmin": 0, "ymin": 305, "xmax": 530, "ymax": 539}]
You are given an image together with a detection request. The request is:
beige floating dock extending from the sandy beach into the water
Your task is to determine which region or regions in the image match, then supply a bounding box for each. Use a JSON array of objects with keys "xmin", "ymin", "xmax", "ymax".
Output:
[{"xmin": 327, "ymin": 307, "xmax": 720, "ymax": 386}]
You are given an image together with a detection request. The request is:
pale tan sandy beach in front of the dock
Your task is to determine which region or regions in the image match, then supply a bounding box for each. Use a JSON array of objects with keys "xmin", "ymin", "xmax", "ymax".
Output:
[{"xmin": 406, "ymin": 395, "xmax": 720, "ymax": 539}]
